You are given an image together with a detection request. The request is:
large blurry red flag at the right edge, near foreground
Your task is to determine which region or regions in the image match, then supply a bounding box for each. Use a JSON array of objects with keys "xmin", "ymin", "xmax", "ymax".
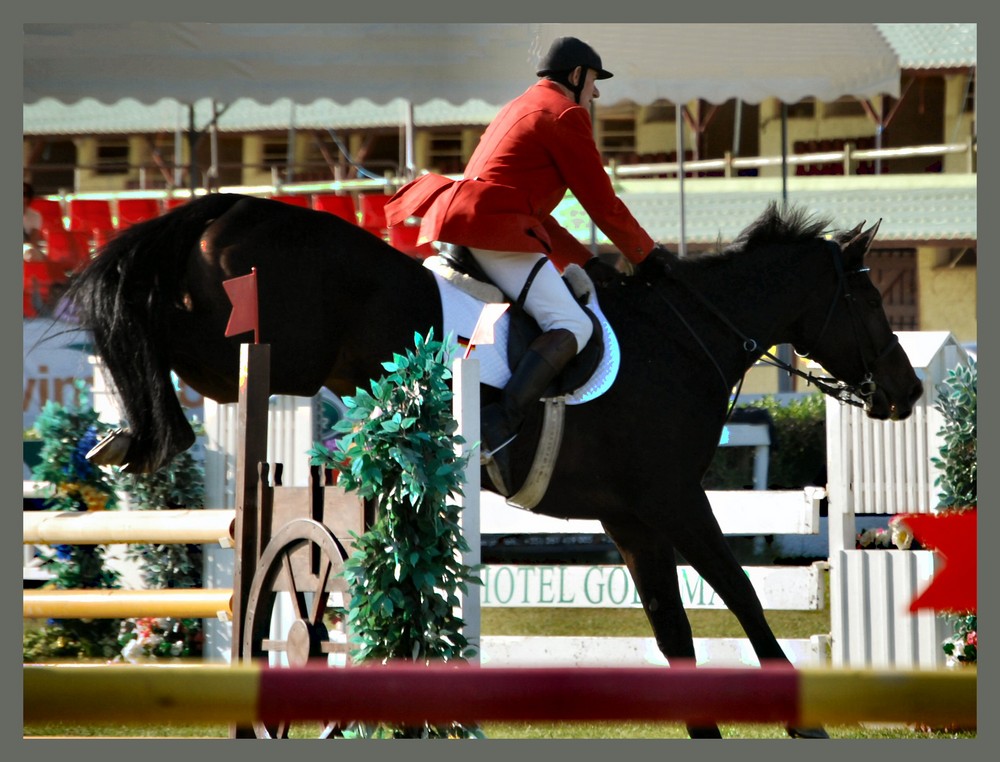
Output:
[{"xmin": 899, "ymin": 510, "xmax": 977, "ymax": 614}]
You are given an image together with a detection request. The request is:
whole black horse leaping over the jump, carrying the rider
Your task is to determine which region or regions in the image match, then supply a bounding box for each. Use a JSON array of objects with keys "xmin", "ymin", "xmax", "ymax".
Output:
[{"xmin": 69, "ymin": 195, "xmax": 922, "ymax": 737}]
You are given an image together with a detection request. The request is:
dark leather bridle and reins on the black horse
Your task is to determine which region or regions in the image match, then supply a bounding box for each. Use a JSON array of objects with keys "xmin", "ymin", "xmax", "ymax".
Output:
[{"xmin": 664, "ymin": 239, "xmax": 899, "ymax": 418}]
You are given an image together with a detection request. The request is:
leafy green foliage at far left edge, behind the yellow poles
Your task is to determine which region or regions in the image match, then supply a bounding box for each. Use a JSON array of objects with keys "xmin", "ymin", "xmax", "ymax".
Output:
[{"xmin": 23, "ymin": 382, "xmax": 119, "ymax": 661}]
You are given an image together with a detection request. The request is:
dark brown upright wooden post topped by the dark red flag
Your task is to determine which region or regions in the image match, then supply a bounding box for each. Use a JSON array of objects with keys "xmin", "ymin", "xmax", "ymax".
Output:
[{"xmin": 230, "ymin": 344, "xmax": 271, "ymax": 738}]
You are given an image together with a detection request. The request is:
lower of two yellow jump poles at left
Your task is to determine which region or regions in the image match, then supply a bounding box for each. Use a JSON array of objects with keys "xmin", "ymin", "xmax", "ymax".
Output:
[{"xmin": 23, "ymin": 588, "xmax": 233, "ymax": 619}]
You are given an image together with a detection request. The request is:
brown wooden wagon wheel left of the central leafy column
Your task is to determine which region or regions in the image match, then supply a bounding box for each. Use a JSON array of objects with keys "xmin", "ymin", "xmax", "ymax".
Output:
[{"xmin": 243, "ymin": 518, "xmax": 347, "ymax": 738}]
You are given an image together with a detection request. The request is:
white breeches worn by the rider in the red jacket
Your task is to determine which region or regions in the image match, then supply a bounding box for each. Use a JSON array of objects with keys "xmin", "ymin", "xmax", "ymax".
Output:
[{"xmin": 469, "ymin": 248, "xmax": 594, "ymax": 354}]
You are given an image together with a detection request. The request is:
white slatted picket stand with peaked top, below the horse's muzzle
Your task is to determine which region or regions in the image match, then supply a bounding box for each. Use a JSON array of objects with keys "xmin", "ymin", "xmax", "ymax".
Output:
[{"xmin": 826, "ymin": 331, "xmax": 967, "ymax": 668}]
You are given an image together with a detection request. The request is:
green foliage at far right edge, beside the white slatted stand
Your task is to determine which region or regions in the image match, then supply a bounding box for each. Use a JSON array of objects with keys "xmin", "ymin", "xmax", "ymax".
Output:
[{"xmin": 931, "ymin": 357, "xmax": 979, "ymax": 664}]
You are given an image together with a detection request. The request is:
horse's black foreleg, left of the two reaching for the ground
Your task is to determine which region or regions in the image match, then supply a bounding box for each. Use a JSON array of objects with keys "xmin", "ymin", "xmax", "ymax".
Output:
[{"xmin": 604, "ymin": 522, "xmax": 722, "ymax": 738}]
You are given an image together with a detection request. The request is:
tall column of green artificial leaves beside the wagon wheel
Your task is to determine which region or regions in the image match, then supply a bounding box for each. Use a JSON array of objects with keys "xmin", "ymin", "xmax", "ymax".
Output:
[{"xmin": 310, "ymin": 331, "xmax": 481, "ymax": 738}]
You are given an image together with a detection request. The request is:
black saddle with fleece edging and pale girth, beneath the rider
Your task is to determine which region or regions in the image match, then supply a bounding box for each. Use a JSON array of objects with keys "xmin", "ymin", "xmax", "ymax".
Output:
[{"xmin": 438, "ymin": 244, "xmax": 605, "ymax": 510}]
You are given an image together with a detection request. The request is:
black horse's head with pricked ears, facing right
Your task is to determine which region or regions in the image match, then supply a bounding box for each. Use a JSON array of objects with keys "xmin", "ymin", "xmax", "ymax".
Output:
[{"xmin": 793, "ymin": 221, "xmax": 923, "ymax": 420}]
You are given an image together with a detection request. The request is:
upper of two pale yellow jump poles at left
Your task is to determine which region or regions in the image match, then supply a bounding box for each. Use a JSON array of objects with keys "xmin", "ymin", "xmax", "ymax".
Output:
[{"xmin": 22, "ymin": 509, "xmax": 236, "ymax": 547}]
